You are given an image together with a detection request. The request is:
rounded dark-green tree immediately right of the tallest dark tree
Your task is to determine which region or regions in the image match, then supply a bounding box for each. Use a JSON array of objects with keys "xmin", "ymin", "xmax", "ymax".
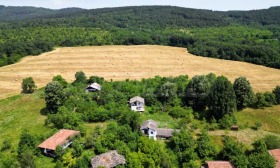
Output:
[{"xmin": 233, "ymin": 77, "xmax": 254, "ymax": 109}]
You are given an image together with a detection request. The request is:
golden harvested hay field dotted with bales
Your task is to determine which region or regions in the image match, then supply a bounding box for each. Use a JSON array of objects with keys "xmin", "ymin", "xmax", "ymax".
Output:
[{"xmin": 0, "ymin": 45, "xmax": 280, "ymax": 98}]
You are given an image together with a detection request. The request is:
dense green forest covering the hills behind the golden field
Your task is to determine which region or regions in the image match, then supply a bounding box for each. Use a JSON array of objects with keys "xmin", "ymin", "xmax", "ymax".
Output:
[{"xmin": 0, "ymin": 6, "xmax": 280, "ymax": 68}]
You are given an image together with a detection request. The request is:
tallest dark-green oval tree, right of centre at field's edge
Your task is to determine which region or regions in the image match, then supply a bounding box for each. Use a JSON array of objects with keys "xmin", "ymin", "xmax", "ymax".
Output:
[{"xmin": 208, "ymin": 76, "xmax": 236, "ymax": 119}]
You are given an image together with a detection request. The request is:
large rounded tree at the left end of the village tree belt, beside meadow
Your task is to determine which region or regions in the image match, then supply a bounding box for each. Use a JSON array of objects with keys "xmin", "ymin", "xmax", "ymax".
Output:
[{"xmin": 45, "ymin": 81, "xmax": 66, "ymax": 113}]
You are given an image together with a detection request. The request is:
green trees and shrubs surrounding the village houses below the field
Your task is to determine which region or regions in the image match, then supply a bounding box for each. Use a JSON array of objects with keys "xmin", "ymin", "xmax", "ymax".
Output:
[{"xmin": 0, "ymin": 71, "xmax": 280, "ymax": 168}]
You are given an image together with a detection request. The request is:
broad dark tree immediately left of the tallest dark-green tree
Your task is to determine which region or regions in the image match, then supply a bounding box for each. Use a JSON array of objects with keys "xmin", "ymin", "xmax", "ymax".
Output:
[{"xmin": 186, "ymin": 75, "xmax": 212, "ymax": 110}]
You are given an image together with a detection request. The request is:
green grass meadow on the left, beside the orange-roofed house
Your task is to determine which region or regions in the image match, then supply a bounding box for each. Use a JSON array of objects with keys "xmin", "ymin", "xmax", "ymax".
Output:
[{"xmin": 0, "ymin": 90, "xmax": 55, "ymax": 168}]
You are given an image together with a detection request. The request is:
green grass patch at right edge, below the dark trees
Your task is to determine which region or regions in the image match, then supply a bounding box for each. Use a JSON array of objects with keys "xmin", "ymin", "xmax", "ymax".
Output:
[{"xmin": 235, "ymin": 105, "xmax": 280, "ymax": 134}]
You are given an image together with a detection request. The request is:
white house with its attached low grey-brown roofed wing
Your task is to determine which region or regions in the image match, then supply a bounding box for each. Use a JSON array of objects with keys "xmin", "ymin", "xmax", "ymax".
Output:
[{"xmin": 140, "ymin": 120, "xmax": 178, "ymax": 140}]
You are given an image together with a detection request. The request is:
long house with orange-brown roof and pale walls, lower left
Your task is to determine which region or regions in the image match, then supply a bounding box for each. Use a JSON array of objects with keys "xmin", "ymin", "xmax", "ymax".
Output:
[{"xmin": 38, "ymin": 129, "xmax": 80, "ymax": 156}]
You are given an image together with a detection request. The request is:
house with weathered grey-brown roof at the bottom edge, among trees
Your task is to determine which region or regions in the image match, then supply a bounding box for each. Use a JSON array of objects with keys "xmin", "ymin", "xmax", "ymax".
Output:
[{"xmin": 91, "ymin": 150, "xmax": 126, "ymax": 168}]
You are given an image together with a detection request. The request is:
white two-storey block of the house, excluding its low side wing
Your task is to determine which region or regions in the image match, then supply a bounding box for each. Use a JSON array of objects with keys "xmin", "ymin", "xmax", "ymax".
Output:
[{"xmin": 140, "ymin": 120, "xmax": 158, "ymax": 140}]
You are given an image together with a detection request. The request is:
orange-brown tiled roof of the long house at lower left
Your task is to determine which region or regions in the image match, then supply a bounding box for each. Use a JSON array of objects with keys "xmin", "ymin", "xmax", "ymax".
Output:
[{"xmin": 38, "ymin": 129, "xmax": 80, "ymax": 150}]
